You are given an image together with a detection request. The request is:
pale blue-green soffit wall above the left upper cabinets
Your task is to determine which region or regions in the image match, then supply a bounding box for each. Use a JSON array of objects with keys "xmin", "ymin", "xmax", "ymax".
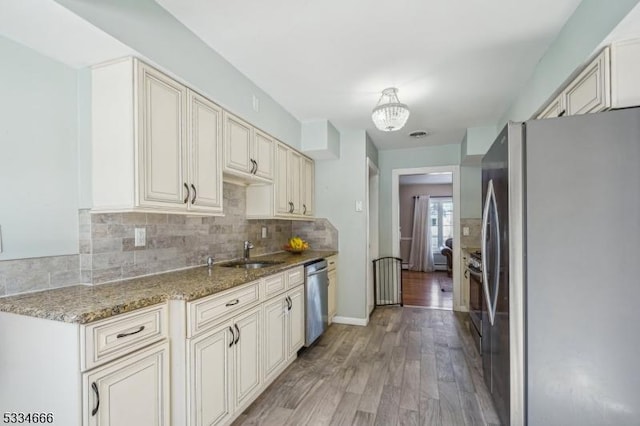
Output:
[{"xmin": 56, "ymin": 0, "xmax": 301, "ymax": 149}]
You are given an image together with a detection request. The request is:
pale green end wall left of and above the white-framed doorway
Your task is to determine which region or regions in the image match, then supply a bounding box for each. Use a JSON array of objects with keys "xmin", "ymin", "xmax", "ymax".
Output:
[{"xmin": 376, "ymin": 143, "xmax": 460, "ymax": 256}]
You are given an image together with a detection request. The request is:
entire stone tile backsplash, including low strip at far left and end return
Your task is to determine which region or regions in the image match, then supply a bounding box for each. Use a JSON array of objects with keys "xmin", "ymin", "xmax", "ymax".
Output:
[{"xmin": 0, "ymin": 182, "xmax": 338, "ymax": 297}]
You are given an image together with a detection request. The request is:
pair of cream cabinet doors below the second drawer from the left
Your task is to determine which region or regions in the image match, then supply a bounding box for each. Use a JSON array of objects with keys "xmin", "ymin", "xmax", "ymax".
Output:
[{"xmin": 188, "ymin": 306, "xmax": 262, "ymax": 425}]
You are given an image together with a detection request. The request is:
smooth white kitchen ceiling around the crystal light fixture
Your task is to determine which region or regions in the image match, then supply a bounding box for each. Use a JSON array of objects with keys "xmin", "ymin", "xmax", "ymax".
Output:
[{"xmin": 156, "ymin": 0, "xmax": 580, "ymax": 149}]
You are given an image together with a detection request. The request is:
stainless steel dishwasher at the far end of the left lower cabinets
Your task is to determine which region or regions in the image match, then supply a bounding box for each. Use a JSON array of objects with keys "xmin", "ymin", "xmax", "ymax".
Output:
[{"xmin": 304, "ymin": 259, "xmax": 329, "ymax": 346}]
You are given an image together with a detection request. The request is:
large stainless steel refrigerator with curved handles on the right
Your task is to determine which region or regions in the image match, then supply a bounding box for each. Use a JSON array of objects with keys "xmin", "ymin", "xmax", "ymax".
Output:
[{"xmin": 482, "ymin": 108, "xmax": 640, "ymax": 426}]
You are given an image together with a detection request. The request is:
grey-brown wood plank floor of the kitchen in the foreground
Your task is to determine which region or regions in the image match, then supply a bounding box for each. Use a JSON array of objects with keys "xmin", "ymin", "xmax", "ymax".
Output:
[{"xmin": 234, "ymin": 307, "xmax": 499, "ymax": 426}]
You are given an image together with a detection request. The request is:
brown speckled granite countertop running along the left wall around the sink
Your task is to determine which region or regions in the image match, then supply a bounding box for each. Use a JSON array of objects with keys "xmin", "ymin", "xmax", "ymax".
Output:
[{"xmin": 0, "ymin": 250, "xmax": 336, "ymax": 324}]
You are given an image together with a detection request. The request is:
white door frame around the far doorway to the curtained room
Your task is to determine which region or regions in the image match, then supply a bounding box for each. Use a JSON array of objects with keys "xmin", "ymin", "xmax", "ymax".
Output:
[{"xmin": 391, "ymin": 165, "xmax": 469, "ymax": 312}]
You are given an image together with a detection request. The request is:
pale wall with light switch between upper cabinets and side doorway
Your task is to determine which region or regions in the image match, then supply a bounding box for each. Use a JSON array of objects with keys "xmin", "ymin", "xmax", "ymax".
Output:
[{"xmin": 315, "ymin": 130, "xmax": 368, "ymax": 320}]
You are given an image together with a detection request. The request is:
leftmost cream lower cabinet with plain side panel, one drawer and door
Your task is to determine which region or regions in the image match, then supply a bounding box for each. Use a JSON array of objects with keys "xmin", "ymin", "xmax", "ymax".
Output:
[{"xmin": 0, "ymin": 304, "xmax": 172, "ymax": 426}]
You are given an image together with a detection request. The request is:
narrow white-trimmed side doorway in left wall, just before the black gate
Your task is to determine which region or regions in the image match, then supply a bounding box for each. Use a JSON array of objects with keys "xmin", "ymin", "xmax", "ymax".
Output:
[{"xmin": 365, "ymin": 157, "xmax": 380, "ymax": 319}]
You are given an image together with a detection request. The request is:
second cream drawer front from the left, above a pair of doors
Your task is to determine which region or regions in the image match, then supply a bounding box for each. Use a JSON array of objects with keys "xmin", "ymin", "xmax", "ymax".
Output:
[{"xmin": 187, "ymin": 281, "xmax": 260, "ymax": 337}]
